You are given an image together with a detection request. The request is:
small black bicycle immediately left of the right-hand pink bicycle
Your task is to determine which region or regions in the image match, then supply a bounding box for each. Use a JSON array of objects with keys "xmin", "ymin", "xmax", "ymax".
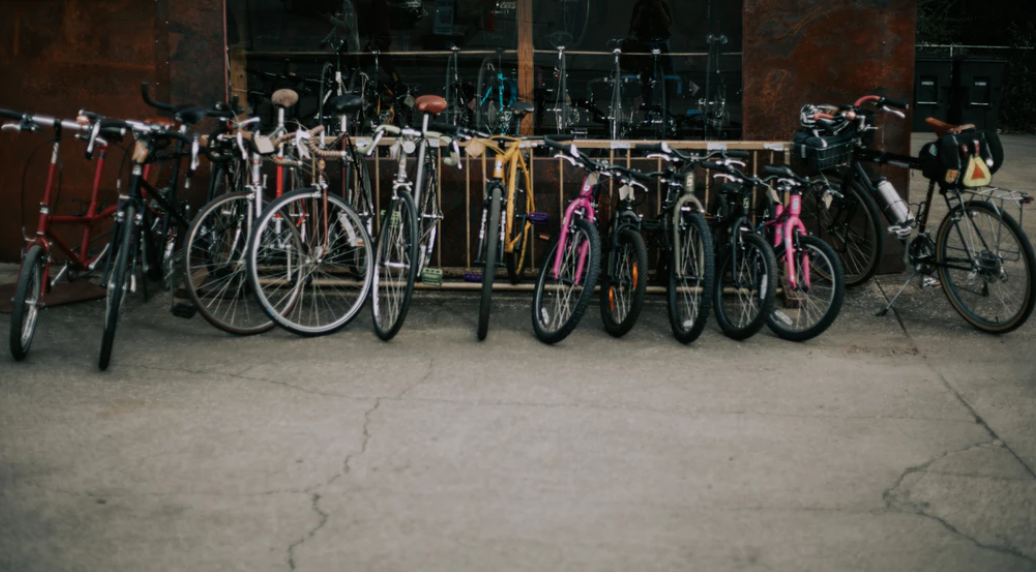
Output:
[{"xmin": 700, "ymin": 160, "xmax": 777, "ymax": 341}]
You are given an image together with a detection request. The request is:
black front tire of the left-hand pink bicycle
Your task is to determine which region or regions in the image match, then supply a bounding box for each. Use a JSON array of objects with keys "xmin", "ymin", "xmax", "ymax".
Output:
[{"xmin": 533, "ymin": 219, "xmax": 601, "ymax": 344}]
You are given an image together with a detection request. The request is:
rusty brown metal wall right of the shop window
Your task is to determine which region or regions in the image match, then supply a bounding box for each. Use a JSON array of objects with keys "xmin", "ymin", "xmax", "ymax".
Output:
[{"xmin": 744, "ymin": 0, "xmax": 916, "ymax": 271}]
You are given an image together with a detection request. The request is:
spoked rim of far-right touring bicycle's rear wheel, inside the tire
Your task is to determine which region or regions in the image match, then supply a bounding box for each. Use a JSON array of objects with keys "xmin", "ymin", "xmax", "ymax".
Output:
[{"xmin": 941, "ymin": 209, "xmax": 1033, "ymax": 326}]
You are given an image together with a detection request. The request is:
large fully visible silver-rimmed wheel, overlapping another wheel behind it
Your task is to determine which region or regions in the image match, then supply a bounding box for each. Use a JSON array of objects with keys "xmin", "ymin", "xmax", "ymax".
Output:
[{"xmin": 248, "ymin": 188, "xmax": 374, "ymax": 336}]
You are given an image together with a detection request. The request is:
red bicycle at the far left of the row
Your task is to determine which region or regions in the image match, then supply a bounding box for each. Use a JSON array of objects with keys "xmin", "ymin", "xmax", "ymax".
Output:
[{"xmin": 0, "ymin": 109, "xmax": 125, "ymax": 361}]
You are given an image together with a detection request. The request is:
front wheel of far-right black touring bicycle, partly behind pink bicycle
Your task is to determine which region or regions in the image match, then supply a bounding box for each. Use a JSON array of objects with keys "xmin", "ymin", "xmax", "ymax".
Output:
[{"xmin": 800, "ymin": 175, "xmax": 885, "ymax": 288}]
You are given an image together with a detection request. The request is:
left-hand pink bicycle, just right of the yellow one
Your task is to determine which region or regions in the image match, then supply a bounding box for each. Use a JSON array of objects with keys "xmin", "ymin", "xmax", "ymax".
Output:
[{"xmin": 533, "ymin": 138, "xmax": 609, "ymax": 344}]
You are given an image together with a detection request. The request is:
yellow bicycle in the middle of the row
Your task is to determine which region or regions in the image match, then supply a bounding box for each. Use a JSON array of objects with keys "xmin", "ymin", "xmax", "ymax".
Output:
[{"xmin": 437, "ymin": 102, "xmax": 547, "ymax": 342}]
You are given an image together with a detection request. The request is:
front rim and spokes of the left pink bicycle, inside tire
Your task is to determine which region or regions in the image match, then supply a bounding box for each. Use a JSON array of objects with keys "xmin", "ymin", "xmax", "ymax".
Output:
[{"xmin": 537, "ymin": 228, "xmax": 589, "ymax": 333}]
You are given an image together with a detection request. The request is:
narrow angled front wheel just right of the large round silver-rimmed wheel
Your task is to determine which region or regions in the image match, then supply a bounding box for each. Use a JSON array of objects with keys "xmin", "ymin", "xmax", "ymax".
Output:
[{"xmin": 371, "ymin": 191, "xmax": 419, "ymax": 342}]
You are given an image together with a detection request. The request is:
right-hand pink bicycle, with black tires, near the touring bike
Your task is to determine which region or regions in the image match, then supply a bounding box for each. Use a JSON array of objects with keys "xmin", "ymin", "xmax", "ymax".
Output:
[{"xmin": 760, "ymin": 165, "xmax": 845, "ymax": 342}]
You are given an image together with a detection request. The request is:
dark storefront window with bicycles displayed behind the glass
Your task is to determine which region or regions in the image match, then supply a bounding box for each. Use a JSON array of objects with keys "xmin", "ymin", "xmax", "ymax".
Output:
[{"xmin": 228, "ymin": 0, "xmax": 742, "ymax": 139}]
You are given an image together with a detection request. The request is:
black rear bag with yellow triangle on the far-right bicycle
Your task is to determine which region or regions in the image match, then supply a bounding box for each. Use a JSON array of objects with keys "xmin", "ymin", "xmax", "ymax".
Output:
[{"xmin": 919, "ymin": 131, "xmax": 1004, "ymax": 189}]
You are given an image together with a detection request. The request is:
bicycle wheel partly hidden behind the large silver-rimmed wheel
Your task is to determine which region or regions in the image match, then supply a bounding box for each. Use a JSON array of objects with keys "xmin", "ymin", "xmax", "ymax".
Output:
[{"xmin": 183, "ymin": 193, "xmax": 274, "ymax": 336}]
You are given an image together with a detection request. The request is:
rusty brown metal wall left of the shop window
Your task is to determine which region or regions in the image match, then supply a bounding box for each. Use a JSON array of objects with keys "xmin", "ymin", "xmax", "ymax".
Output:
[{"xmin": 0, "ymin": 0, "xmax": 225, "ymax": 261}]
